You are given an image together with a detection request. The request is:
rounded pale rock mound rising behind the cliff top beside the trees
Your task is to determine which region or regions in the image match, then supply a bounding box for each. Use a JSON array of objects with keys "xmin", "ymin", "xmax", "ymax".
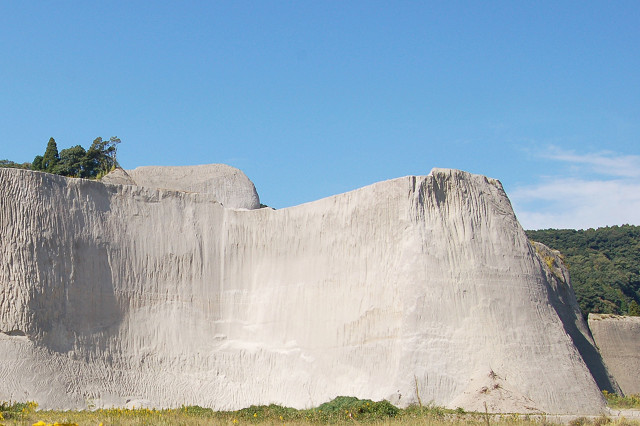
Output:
[{"xmin": 102, "ymin": 164, "xmax": 260, "ymax": 210}]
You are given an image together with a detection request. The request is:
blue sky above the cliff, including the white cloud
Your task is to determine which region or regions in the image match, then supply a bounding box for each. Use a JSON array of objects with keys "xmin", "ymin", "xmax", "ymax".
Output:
[{"xmin": 0, "ymin": 0, "xmax": 640, "ymax": 229}]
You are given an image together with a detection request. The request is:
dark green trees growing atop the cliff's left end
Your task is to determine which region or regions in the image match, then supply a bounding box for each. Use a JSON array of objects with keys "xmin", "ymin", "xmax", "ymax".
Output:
[{"xmin": 0, "ymin": 137, "xmax": 120, "ymax": 179}]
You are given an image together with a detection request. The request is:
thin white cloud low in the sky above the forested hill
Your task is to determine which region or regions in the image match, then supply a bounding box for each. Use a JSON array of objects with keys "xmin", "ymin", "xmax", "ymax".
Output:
[{"xmin": 509, "ymin": 147, "xmax": 640, "ymax": 229}]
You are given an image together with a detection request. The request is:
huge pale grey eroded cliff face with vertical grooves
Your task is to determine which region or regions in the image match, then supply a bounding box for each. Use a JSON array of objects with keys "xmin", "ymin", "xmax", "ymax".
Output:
[{"xmin": 0, "ymin": 169, "xmax": 604, "ymax": 413}]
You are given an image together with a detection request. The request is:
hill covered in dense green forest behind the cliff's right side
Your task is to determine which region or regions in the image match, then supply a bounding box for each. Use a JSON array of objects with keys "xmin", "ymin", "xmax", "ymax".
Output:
[{"xmin": 526, "ymin": 225, "xmax": 640, "ymax": 315}]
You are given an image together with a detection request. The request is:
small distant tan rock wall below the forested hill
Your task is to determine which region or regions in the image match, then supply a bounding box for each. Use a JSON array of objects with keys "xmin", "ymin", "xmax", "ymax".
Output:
[{"xmin": 589, "ymin": 314, "xmax": 640, "ymax": 395}]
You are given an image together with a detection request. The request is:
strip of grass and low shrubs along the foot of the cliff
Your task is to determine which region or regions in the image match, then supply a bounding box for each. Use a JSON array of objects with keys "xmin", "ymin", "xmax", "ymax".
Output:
[{"xmin": 0, "ymin": 393, "xmax": 640, "ymax": 426}]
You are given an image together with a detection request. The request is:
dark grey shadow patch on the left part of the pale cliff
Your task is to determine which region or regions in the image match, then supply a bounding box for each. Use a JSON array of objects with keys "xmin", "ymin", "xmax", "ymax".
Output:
[{"xmin": 29, "ymin": 181, "xmax": 122, "ymax": 353}]
